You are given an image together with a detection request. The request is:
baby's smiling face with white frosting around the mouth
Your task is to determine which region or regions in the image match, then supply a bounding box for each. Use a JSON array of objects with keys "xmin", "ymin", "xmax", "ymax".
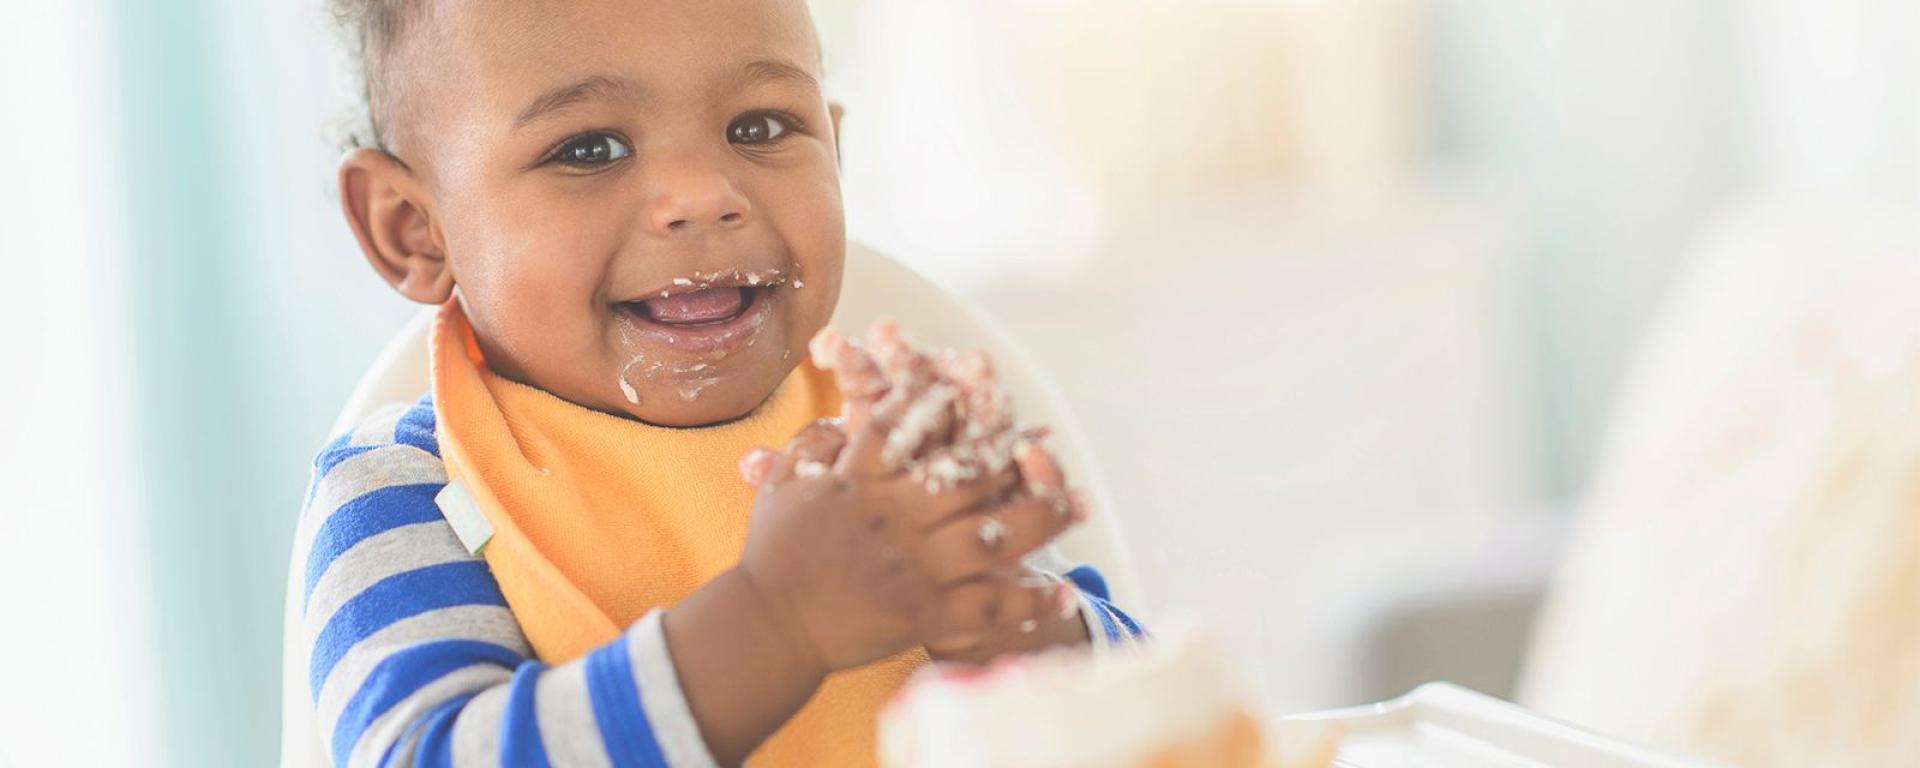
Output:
[{"xmin": 396, "ymin": 0, "xmax": 845, "ymax": 426}]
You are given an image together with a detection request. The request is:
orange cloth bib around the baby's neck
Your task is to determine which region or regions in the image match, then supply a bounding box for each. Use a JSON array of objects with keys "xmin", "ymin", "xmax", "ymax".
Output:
[{"xmin": 432, "ymin": 301, "xmax": 925, "ymax": 766}]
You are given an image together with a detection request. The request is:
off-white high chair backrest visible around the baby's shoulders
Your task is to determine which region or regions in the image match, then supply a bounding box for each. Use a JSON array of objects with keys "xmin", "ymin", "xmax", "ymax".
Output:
[{"xmin": 280, "ymin": 244, "xmax": 1139, "ymax": 768}]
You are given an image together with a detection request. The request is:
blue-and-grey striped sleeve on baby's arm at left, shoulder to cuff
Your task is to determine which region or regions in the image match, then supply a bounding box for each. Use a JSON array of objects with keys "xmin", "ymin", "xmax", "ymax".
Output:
[{"xmin": 296, "ymin": 399, "xmax": 714, "ymax": 768}]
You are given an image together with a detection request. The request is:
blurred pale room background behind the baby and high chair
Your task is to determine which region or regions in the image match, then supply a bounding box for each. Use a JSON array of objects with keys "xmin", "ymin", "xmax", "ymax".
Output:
[{"xmin": 0, "ymin": 0, "xmax": 1920, "ymax": 766}]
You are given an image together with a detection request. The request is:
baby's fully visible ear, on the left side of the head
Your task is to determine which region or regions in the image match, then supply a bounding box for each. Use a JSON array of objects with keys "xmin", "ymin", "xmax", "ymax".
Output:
[{"xmin": 340, "ymin": 148, "xmax": 453, "ymax": 303}]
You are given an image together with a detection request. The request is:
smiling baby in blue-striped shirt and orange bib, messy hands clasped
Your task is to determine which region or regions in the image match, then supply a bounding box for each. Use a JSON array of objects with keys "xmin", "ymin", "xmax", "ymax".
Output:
[{"xmin": 296, "ymin": 0, "xmax": 1139, "ymax": 766}]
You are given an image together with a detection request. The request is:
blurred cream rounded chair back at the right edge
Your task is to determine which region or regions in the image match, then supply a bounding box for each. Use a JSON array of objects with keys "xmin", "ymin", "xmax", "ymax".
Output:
[{"xmin": 1521, "ymin": 200, "xmax": 1920, "ymax": 768}]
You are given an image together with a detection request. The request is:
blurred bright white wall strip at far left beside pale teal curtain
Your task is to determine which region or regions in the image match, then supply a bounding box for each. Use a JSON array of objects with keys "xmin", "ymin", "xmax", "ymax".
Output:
[{"xmin": 0, "ymin": 2, "xmax": 157, "ymax": 766}]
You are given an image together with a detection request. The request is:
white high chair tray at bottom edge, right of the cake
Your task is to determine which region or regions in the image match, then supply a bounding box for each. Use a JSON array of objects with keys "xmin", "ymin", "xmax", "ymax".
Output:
[{"xmin": 1271, "ymin": 684, "xmax": 1715, "ymax": 768}]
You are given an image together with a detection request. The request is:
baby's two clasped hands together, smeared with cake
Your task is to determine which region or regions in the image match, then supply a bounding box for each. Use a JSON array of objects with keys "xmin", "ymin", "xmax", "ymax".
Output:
[{"xmin": 739, "ymin": 323, "xmax": 1087, "ymax": 670}]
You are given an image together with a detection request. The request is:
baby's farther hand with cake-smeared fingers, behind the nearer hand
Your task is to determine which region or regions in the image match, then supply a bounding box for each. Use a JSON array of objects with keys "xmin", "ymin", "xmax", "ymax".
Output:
[{"xmin": 741, "ymin": 324, "xmax": 1087, "ymax": 660}]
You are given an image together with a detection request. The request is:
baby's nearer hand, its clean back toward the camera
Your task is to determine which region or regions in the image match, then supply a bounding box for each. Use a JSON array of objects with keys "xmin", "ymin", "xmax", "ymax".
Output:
[{"xmin": 739, "ymin": 416, "xmax": 1071, "ymax": 670}]
